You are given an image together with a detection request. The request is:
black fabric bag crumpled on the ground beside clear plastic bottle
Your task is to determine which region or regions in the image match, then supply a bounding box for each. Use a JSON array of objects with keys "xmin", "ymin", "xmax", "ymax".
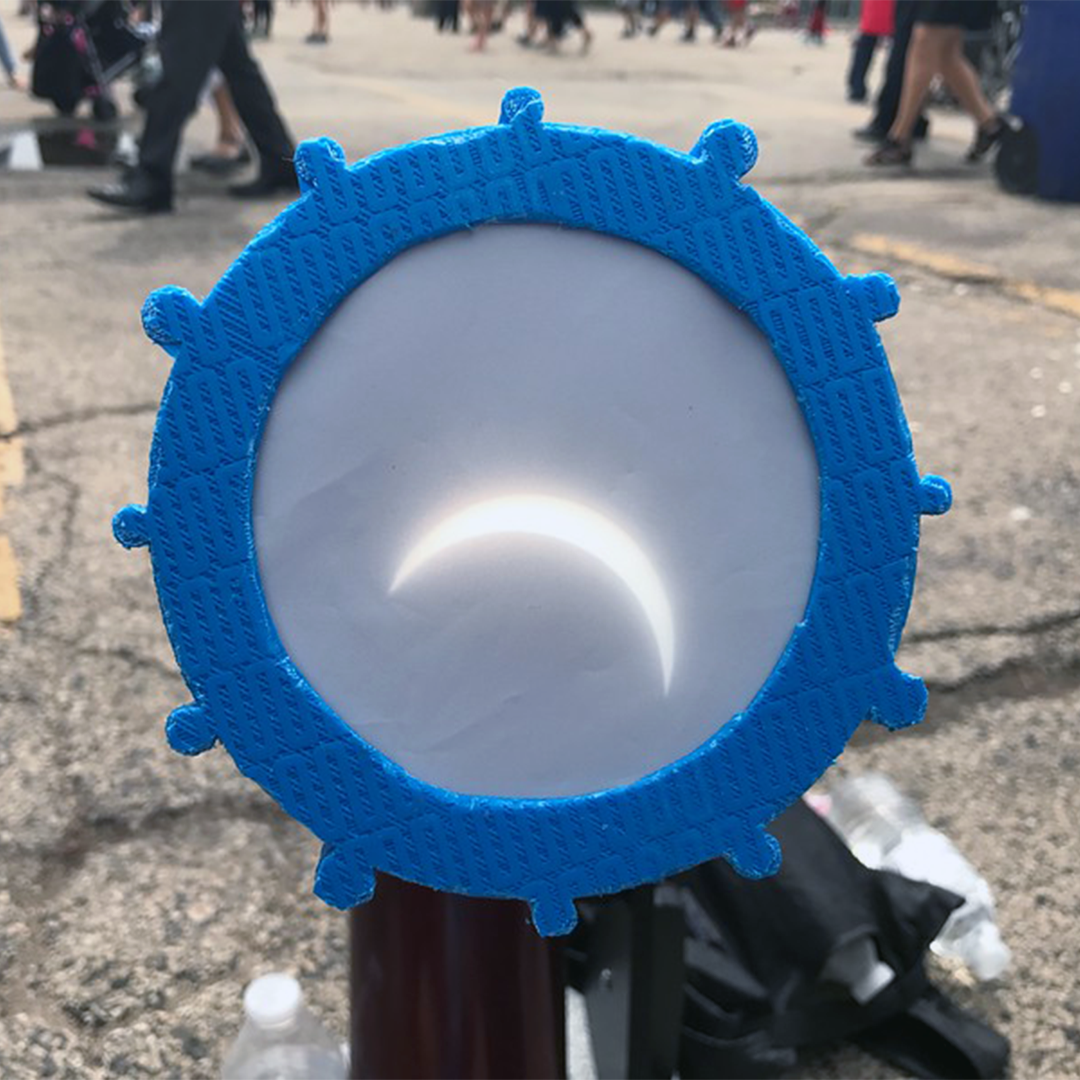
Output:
[{"xmin": 665, "ymin": 802, "xmax": 1009, "ymax": 1080}]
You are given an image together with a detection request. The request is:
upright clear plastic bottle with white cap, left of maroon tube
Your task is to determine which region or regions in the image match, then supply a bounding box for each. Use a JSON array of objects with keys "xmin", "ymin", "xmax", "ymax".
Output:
[{"xmin": 221, "ymin": 974, "xmax": 346, "ymax": 1080}]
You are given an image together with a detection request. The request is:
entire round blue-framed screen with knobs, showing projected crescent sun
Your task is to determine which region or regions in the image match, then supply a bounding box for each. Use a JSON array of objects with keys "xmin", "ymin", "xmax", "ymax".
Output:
[{"xmin": 114, "ymin": 90, "xmax": 949, "ymax": 934}]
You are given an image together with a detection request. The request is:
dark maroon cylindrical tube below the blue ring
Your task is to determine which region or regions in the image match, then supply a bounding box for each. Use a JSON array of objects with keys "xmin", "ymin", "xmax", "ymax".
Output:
[{"xmin": 349, "ymin": 875, "xmax": 566, "ymax": 1080}]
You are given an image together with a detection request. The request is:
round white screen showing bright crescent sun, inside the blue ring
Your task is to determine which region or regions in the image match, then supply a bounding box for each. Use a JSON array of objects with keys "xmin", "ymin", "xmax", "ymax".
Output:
[{"xmin": 253, "ymin": 225, "xmax": 820, "ymax": 798}]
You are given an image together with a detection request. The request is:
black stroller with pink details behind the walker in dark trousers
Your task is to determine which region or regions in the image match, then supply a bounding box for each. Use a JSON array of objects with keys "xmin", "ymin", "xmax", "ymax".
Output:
[{"xmin": 30, "ymin": 0, "xmax": 154, "ymax": 120}]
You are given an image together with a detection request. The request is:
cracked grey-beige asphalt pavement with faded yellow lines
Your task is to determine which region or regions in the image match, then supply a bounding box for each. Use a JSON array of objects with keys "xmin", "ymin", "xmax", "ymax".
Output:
[{"xmin": 0, "ymin": 3, "xmax": 1080, "ymax": 1080}]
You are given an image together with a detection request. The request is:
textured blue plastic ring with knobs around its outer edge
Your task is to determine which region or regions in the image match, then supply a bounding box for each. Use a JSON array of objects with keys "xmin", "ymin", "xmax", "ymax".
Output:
[{"xmin": 114, "ymin": 89, "xmax": 950, "ymax": 934}]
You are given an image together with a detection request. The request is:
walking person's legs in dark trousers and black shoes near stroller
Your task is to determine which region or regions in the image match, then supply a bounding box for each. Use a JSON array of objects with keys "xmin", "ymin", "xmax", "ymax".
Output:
[{"xmin": 87, "ymin": 0, "xmax": 298, "ymax": 214}]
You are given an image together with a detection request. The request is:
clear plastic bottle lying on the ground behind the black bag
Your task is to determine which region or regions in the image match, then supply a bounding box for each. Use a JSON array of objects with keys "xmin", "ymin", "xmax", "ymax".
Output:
[{"xmin": 823, "ymin": 772, "xmax": 1012, "ymax": 980}]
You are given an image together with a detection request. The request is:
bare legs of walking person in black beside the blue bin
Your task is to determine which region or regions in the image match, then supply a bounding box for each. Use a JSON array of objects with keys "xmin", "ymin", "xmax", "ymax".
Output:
[{"xmin": 866, "ymin": 0, "xmax": 1005, "ymax": 165}]
